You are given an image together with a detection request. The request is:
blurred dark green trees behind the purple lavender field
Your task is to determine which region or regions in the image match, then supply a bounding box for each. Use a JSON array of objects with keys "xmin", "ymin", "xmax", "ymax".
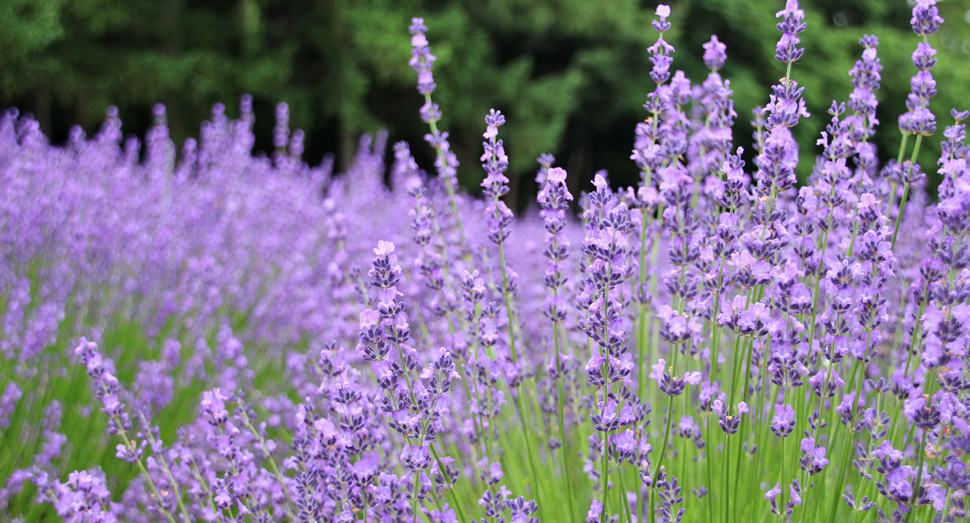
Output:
[{"xmin": 0, "ymin": 0, "xmax": 970, "ymax": 208}]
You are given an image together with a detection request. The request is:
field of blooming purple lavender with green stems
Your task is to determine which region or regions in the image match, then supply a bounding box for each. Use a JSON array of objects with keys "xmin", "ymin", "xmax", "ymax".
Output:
[{"xmin": 0, "ymin": 0, "xmax": 970, "ymax": 523}]
